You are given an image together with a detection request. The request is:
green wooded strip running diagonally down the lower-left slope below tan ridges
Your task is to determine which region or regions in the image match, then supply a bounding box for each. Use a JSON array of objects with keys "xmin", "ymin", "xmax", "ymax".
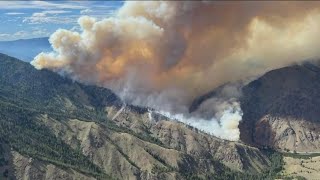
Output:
[{"xmin": 0, "ymin": 104, "xmax": 105, "ymax": 177}]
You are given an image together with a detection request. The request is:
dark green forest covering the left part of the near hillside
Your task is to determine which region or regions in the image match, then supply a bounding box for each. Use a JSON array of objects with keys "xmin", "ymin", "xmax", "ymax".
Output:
[{"xmin": 0, "ymin": 54, "xmax": 124, "ymax": 179}]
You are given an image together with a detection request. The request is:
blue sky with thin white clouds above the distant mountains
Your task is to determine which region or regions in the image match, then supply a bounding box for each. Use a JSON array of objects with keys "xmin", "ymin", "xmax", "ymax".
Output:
[{"xmin": 0, "ymin": 1, "xmax": 124, "ymax": 41}]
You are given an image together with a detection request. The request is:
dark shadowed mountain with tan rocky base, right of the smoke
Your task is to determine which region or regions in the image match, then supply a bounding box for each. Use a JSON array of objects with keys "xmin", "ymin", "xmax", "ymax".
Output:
[{"xmin": 240, "ymin": 63, "xmax": 320, "ymax": 153}]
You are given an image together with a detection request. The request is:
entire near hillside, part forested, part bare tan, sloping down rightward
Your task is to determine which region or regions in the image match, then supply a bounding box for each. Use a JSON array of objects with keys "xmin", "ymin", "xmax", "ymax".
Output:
[{"xmin": 0, "ymin": 54, "xmax": 282, "ymax": 179}]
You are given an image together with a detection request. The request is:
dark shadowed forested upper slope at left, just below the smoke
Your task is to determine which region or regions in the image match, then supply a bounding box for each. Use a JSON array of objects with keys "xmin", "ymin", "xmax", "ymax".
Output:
[{"xmin": 0, "ymin": 54, "xmax": 121, "ymax": 114}]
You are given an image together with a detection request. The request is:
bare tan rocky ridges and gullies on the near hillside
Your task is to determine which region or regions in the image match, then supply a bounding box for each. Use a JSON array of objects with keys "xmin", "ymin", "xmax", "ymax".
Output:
[{"xmin": 38, "ymin": 107, "xmax": 270, "ymax": 179}]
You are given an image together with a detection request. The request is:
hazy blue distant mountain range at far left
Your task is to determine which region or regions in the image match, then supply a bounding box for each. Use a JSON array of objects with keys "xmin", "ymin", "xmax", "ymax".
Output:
[{"xmin": 0, "ymin": 37, "xmax": 52, "ymax": 62}]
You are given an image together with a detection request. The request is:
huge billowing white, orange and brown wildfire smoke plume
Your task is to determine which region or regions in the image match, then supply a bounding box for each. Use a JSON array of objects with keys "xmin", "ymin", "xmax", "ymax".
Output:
[{"xmin": 32, "ymin": 1, "xmax": 320, "ymax": 140}]
